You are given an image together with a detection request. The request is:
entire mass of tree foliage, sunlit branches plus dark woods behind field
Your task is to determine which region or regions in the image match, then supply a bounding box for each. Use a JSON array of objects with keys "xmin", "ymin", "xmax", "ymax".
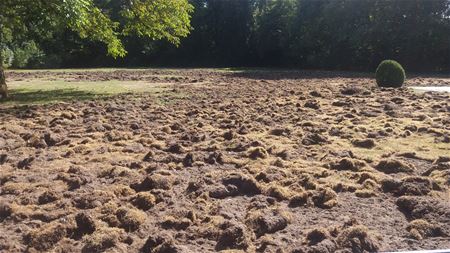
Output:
[{"xmin": 0, "ymin": 0, "xmax": 450, "ymax": 71}]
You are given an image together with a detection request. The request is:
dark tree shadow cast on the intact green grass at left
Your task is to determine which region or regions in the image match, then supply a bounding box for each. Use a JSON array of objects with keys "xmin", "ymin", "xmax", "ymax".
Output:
[{"xmin": 0, "ymin": 89, "xmax": 107, "ymax": 105}]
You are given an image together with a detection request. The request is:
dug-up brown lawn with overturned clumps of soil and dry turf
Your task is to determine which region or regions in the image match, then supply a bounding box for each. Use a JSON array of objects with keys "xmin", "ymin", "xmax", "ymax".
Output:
[{"xmin": 0, "ymin": 69, "xmax": 450, "ymax": 253}]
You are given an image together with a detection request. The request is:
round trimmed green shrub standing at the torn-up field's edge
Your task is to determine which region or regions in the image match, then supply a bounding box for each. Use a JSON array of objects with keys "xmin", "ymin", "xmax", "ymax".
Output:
[{"xmin": 376, "ymin": 60, "xmax": 405, "ymax": 88}]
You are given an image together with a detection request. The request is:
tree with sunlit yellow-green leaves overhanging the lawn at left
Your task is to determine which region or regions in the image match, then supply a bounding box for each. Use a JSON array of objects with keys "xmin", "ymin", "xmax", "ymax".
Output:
[{"xmin": 0, "ymin": 0, "xmax": 193, "ymax": 98}]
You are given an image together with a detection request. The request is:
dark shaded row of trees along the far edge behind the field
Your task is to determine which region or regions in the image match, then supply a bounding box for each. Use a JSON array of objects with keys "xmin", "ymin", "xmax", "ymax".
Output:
[{"xmin": 4, "ymin": 0, "xmax": 450, "ymax": 71}]
